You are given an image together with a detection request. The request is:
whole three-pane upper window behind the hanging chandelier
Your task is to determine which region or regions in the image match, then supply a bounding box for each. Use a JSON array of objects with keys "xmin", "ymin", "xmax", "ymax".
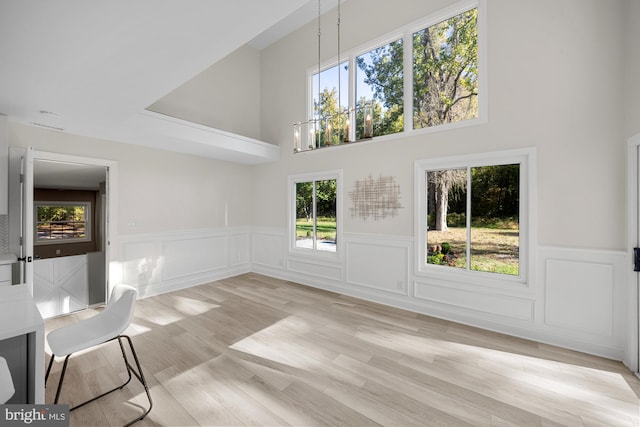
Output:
[{"xmin": 304, "ymin": 0, "xmax": 486, "ymax": 151}]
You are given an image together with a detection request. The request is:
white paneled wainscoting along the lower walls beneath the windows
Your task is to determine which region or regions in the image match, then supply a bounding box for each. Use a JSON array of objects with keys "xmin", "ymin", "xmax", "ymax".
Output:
[{"xmin": 114, "ymin": 227, "xmax": 627, "ymax": 360}]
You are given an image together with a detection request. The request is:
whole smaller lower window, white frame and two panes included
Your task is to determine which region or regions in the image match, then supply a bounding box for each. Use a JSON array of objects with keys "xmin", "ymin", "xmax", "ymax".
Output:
[{"xmin": 289, "ymin": 172, "xmax": 341, "ymax": 253}]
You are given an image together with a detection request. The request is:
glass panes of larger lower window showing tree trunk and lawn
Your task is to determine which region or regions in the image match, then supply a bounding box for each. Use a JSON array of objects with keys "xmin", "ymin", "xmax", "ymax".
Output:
[{"xmin": 425, "ymin": 164, "xmax": 520, "ymax": 276}]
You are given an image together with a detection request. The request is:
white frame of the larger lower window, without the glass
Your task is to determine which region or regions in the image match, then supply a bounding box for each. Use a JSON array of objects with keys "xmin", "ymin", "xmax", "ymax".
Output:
[{"xmin": 414, "ymin": 148, "xmax": 536, "ymax": 289}]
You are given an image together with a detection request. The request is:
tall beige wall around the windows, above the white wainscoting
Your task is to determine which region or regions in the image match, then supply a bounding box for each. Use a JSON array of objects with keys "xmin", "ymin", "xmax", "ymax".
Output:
[{"xmin": 253, "ymin": 0, "xmax": 629, "ymax": 249}]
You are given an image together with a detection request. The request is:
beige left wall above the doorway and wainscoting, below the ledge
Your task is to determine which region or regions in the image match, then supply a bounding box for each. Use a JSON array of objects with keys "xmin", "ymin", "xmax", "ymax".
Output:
[{"xmin": 9, "ymin": 123, "xmax": 252, "ymax": 235}]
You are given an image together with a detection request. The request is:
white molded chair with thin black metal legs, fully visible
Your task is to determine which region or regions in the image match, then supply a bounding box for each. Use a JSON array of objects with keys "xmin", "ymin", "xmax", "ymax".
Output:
[{"xmin": 45, "ymin": 285, "xmax": 153, "ymax": 426}]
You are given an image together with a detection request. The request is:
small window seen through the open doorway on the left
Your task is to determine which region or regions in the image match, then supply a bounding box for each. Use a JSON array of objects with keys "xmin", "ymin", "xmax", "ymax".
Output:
[{"xmin": 34, "ymin": 202, "xmax": 91, "ymax": 244}]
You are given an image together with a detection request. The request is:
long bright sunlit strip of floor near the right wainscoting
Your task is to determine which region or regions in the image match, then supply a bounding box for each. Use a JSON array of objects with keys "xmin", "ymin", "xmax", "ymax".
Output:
[{"xmin": 357, "ymin": 328, "xmax": 640, "ymax": 425}]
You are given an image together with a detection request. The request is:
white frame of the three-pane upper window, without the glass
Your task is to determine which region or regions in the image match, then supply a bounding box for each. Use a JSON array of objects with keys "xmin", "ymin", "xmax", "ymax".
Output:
[{"xmin": 304, "ymin": 0, "xmax": 489, "ymax": 147}]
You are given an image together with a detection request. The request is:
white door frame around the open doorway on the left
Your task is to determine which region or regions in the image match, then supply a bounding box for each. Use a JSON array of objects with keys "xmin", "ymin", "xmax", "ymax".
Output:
[{"xmin": 8, "ymin": 147, "xmax": 119, "ymax": 302}]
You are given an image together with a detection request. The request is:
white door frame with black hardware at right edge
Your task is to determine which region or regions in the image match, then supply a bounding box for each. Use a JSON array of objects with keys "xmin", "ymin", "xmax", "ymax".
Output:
[{"xmin": 623, "ymin": 133, "xmax": 640, "ymax": 375}]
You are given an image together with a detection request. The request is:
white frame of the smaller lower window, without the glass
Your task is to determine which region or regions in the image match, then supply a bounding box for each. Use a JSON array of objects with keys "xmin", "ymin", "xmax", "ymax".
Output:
[{"xmin": 287, "ymin": 169, "xmax": 344, "ymax": 260}]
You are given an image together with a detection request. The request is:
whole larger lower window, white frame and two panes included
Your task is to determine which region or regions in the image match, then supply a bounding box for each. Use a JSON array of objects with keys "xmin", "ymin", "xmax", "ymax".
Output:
[{"xmin": 416, "ymin": 150, "xmax": 530, "ymax": 281}]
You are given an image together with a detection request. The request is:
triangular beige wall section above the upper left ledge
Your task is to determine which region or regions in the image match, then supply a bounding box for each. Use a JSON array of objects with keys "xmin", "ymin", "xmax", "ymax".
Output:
[{"xmin": 148, "ymin": 46, "xmax": 260, "ymax": 139}]
